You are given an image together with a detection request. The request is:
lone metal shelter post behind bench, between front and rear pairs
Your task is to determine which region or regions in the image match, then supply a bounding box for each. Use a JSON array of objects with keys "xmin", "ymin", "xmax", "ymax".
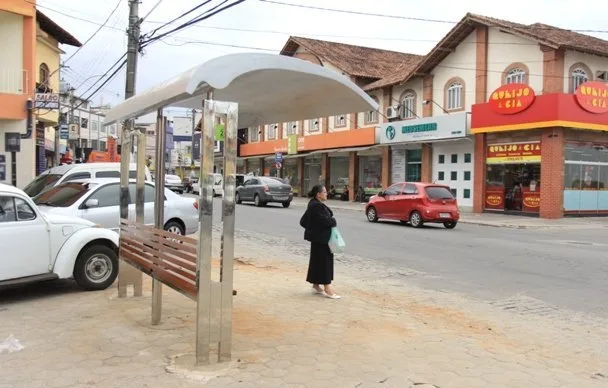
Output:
[{"xmin": 152, "ymin": 109, "xmax": 166, "ymax": 325}]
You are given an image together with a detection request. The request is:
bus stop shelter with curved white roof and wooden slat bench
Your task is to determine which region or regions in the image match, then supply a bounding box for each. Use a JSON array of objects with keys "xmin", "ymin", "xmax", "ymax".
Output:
[{"xmin": 104, "ymin": 53, "xmax": 378, "ymax": 365}]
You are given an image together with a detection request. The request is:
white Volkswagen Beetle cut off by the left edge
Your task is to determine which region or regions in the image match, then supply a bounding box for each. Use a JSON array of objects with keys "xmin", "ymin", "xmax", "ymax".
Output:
[{"xmin": 0, "ymin": 183, "xmax": 118, "ymax": 290}]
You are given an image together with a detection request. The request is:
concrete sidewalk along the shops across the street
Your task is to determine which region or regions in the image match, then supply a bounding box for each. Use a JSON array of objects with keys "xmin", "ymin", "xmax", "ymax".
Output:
[{"xmin": 292, "ymin": 198, "xmax": 608, "ymax": 229}]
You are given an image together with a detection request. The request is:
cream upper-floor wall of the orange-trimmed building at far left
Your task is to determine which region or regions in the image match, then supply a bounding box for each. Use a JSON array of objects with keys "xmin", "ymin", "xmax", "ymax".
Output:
[{"xmin": 0, "ymin": 11, "xmax": 23, "ymax": 93}]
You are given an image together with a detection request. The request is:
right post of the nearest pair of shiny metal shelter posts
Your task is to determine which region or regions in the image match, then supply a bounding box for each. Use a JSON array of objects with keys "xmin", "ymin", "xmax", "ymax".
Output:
[{"xmin": 218, "ymin": 104, "xmax": 238, "ymax": 362}]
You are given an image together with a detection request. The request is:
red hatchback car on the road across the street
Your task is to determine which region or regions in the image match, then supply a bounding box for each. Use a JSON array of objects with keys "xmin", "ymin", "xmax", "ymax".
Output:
[{"xmin": 365, "ymin": 182, "xmax": 460, "ymax": 229}]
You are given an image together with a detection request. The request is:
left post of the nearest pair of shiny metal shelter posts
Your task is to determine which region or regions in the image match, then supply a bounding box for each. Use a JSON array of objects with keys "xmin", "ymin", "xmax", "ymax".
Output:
[{"xmin": 196, "ymin": 91, "xmax": 215, "ymax": 365}]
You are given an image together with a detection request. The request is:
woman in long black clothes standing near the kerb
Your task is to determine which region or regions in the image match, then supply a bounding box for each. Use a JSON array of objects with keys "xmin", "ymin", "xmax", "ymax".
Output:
[{"xmin": 300, "ymin": 185, "xmax": 340, "ymax": 299}]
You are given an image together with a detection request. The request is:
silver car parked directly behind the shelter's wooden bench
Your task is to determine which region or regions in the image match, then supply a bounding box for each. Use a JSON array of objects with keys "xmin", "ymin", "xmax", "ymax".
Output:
[{"xmin": 34, "ymin": 179, "xmax": 198, "ymax": 235}]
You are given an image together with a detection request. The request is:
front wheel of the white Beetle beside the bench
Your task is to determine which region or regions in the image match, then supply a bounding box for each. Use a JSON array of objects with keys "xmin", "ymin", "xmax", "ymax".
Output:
[{"xmin": 74, "ymin": 245, "xmax": 118, "ymax": 291}]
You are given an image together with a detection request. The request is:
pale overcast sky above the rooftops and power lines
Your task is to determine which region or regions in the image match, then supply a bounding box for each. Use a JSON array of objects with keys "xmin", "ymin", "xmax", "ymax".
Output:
[{"xmin": 38, "ymin": 0, "xmax": 608, "ymax": 112}]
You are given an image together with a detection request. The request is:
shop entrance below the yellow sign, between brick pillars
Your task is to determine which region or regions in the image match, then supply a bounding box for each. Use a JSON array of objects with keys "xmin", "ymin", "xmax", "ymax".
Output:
[{"xmin": 485, "ymin": 163, "xmax": 541, "ymax": 213}]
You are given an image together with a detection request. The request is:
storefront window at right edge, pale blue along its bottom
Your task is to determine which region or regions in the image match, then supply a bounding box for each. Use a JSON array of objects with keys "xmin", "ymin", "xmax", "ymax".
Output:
[{"xmin": 564, "ymin": 143, "xmax": 608, "ymax": 213}]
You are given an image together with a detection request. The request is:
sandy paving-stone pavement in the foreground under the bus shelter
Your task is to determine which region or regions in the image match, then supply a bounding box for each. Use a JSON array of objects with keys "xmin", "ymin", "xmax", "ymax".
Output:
[{"xmin": 0, "ymin": 232, "xmax": 608, "ymax": 388}]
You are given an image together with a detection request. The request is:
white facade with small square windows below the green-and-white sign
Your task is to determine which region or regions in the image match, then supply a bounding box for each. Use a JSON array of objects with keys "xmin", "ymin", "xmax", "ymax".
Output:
[{"xmin": 432, "ymin": 140, "xmax": 475, "ymax": 208}]
